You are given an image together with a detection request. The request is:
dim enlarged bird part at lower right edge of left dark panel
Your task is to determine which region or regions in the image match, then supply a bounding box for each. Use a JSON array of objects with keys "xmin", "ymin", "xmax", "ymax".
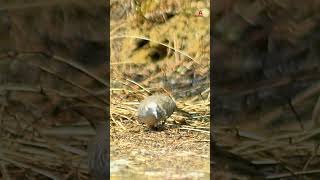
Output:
[{"xmin": 88, "ymin": 123, "xmax": 110, "ymax": 180}]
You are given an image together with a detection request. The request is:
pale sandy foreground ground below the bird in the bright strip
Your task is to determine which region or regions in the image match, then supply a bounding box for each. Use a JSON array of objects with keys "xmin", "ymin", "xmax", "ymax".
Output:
[{"xmin": 110, "ymin": 119, "xmax": 210, "ymax": 179}]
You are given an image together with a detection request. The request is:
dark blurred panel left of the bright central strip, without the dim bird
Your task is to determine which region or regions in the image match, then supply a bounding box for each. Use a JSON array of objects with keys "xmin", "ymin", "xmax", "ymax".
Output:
[{"xmin": 0, "ymin": 1, "xmax": 108, "ymax": 179}]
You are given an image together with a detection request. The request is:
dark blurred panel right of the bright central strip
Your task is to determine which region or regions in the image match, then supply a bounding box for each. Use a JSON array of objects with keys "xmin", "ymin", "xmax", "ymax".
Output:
[{"xmin": 211, "ymin": 0, "xmax": 320, "ymax": 179}]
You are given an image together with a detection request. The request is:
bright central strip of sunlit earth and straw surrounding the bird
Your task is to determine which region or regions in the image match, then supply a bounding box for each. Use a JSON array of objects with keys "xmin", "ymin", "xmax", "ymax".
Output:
[{"xmin": 110, "ymin": 1, "xmax": 210, "ymax": 179}]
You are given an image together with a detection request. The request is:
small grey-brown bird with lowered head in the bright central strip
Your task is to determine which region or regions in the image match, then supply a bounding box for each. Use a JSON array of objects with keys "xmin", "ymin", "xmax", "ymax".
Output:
[{"xmin": 137, "ymin": 94, "xmax": 177, "ymax": 129}]
